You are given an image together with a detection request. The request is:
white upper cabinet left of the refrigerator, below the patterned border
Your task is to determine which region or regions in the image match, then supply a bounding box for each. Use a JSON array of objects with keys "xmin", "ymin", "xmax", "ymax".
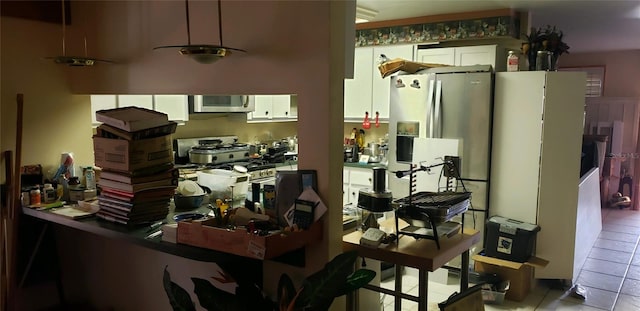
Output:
[{"xmin": 344, "ymin": 45, "xmax": 414, "ymax": 125}]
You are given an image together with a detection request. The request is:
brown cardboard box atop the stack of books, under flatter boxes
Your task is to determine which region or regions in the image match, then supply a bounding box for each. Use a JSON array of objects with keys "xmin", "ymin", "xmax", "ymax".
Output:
[{"xmin": 93, "ymin": 135, "xmax": 173, "ymax": 172}]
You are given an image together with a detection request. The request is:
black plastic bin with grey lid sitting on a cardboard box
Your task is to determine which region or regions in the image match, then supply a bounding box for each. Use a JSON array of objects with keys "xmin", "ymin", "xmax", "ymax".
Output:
[{"xmin": 485, "ymin": 216, "xmax": 540, "ymax": 262}]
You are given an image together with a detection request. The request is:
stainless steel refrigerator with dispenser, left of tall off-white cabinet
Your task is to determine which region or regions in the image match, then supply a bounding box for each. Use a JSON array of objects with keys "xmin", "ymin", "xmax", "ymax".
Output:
[{"xmin": 387, "ymin": 65, "xmax": 493, "ymax": 230}]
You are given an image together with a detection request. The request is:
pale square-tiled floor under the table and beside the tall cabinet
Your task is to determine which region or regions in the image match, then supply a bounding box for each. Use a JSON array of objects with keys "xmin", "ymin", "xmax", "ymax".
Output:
[{"xmin": 381, "ymin": 208, "xmax": 640, "ymax": 311}]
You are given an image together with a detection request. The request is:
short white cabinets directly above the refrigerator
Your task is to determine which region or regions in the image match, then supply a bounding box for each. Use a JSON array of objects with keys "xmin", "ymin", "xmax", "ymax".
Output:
[{"xmin": 416, "ymin": 44, "xmax": 507, "ymax": 72}]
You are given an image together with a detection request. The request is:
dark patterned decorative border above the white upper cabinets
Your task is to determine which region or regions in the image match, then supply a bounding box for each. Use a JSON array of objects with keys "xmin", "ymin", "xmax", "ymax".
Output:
[{"xmin": 356, "ymin": 16, "xmax": 520, "ymax": 47}]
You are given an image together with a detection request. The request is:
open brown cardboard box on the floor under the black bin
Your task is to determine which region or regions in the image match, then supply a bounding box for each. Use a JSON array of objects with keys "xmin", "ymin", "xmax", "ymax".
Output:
[{"xmin": 471, "ymin": 255, "xmax": 549, "ymax": 301}]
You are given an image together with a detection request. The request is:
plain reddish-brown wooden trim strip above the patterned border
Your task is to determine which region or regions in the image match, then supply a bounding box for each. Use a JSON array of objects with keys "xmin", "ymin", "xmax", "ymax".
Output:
[{"xmin": 356, "ymin": 9, "xmax": 517, "ymax": 30}]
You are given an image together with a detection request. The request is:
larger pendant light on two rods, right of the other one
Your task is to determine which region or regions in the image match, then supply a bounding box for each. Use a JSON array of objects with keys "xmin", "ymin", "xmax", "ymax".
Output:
[{"xmin": 153, "ymin": 0, "xmax": 247, "ymax": 64}]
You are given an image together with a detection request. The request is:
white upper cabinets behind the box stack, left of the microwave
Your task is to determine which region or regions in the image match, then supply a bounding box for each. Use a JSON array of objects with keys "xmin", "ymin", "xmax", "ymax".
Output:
[{"xmin": 91, "ymin": 95, "xmax": 189, "ymax": 126}]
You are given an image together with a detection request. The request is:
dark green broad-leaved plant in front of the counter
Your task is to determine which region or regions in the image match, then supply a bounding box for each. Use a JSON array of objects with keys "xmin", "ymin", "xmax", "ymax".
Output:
[{"xmin": 163, "ymin": 251, "xmax": 376, "ymax": 311}]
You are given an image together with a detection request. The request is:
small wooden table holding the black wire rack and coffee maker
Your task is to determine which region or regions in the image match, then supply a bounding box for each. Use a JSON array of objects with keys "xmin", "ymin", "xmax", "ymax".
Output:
[{"xmin": 342, "ymin": 228, "xmax": 480, "ymax": 311}]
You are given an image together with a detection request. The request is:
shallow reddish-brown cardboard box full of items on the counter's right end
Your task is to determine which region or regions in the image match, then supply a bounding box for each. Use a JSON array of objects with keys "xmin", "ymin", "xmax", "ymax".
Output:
[{"xmin": 178, "ymin": 219, "xmax": 323, "ymax": 259}]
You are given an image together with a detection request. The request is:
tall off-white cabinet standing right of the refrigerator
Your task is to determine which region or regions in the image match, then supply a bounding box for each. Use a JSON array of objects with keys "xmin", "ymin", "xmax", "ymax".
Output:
[{"xmin": 489, "ymin": 71, "xmax": 600, "ymax": 280}]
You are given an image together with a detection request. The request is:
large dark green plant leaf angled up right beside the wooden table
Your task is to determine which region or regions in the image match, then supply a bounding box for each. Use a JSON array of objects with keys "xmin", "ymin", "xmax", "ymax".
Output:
[{"xmin": 295, "ymin": 251, "xmax": 358, "ymax": 310}]
